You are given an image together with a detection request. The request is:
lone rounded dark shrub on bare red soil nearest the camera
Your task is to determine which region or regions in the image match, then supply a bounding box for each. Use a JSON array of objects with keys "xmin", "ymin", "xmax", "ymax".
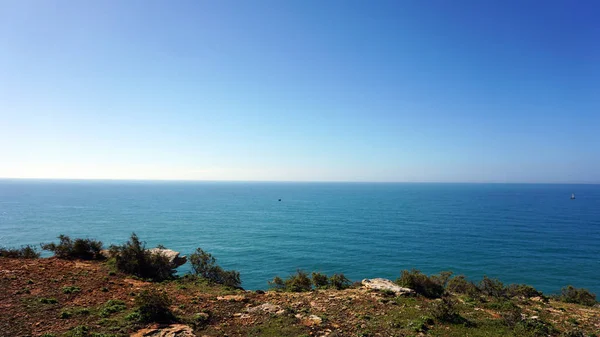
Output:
[{"xmin": 135, "ymin": 289, "xmax": 174, "ymax": 323}]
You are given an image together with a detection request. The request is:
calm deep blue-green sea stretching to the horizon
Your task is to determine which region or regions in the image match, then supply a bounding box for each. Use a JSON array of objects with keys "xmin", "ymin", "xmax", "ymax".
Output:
[{"xmin": 0, "ymin": 180, "xmax": 600, "ymax": 294}]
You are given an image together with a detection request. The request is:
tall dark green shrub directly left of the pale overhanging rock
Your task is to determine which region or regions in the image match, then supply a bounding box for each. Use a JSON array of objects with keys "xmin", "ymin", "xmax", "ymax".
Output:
[{"xmin": 110, "ymin": 233, "xmax": 175, "ymax": 281}]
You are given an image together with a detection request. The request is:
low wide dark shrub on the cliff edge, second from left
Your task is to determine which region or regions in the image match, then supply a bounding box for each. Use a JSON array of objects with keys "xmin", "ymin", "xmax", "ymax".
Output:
[{"xmin": 42, "ymin": 235, "xmax": 104, "ymax": 260}]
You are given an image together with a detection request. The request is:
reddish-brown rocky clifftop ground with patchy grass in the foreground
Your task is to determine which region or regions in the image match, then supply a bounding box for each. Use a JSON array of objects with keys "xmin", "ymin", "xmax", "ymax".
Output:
[{"xmin": 0, "ymin": 258, "xmax": 600, "ymax": 337}]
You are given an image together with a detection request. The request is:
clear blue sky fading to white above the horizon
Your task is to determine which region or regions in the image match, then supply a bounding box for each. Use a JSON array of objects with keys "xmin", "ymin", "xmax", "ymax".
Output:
[{"xmin": 0, "ymin": 0, "xmax": 600, "ymax": 183}]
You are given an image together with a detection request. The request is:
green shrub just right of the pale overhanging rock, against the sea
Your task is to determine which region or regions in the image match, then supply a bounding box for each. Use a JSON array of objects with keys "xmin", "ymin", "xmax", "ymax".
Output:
[{"xmin": 190, "ymin": 248, "xmax": 242, "ymax": 288}]
